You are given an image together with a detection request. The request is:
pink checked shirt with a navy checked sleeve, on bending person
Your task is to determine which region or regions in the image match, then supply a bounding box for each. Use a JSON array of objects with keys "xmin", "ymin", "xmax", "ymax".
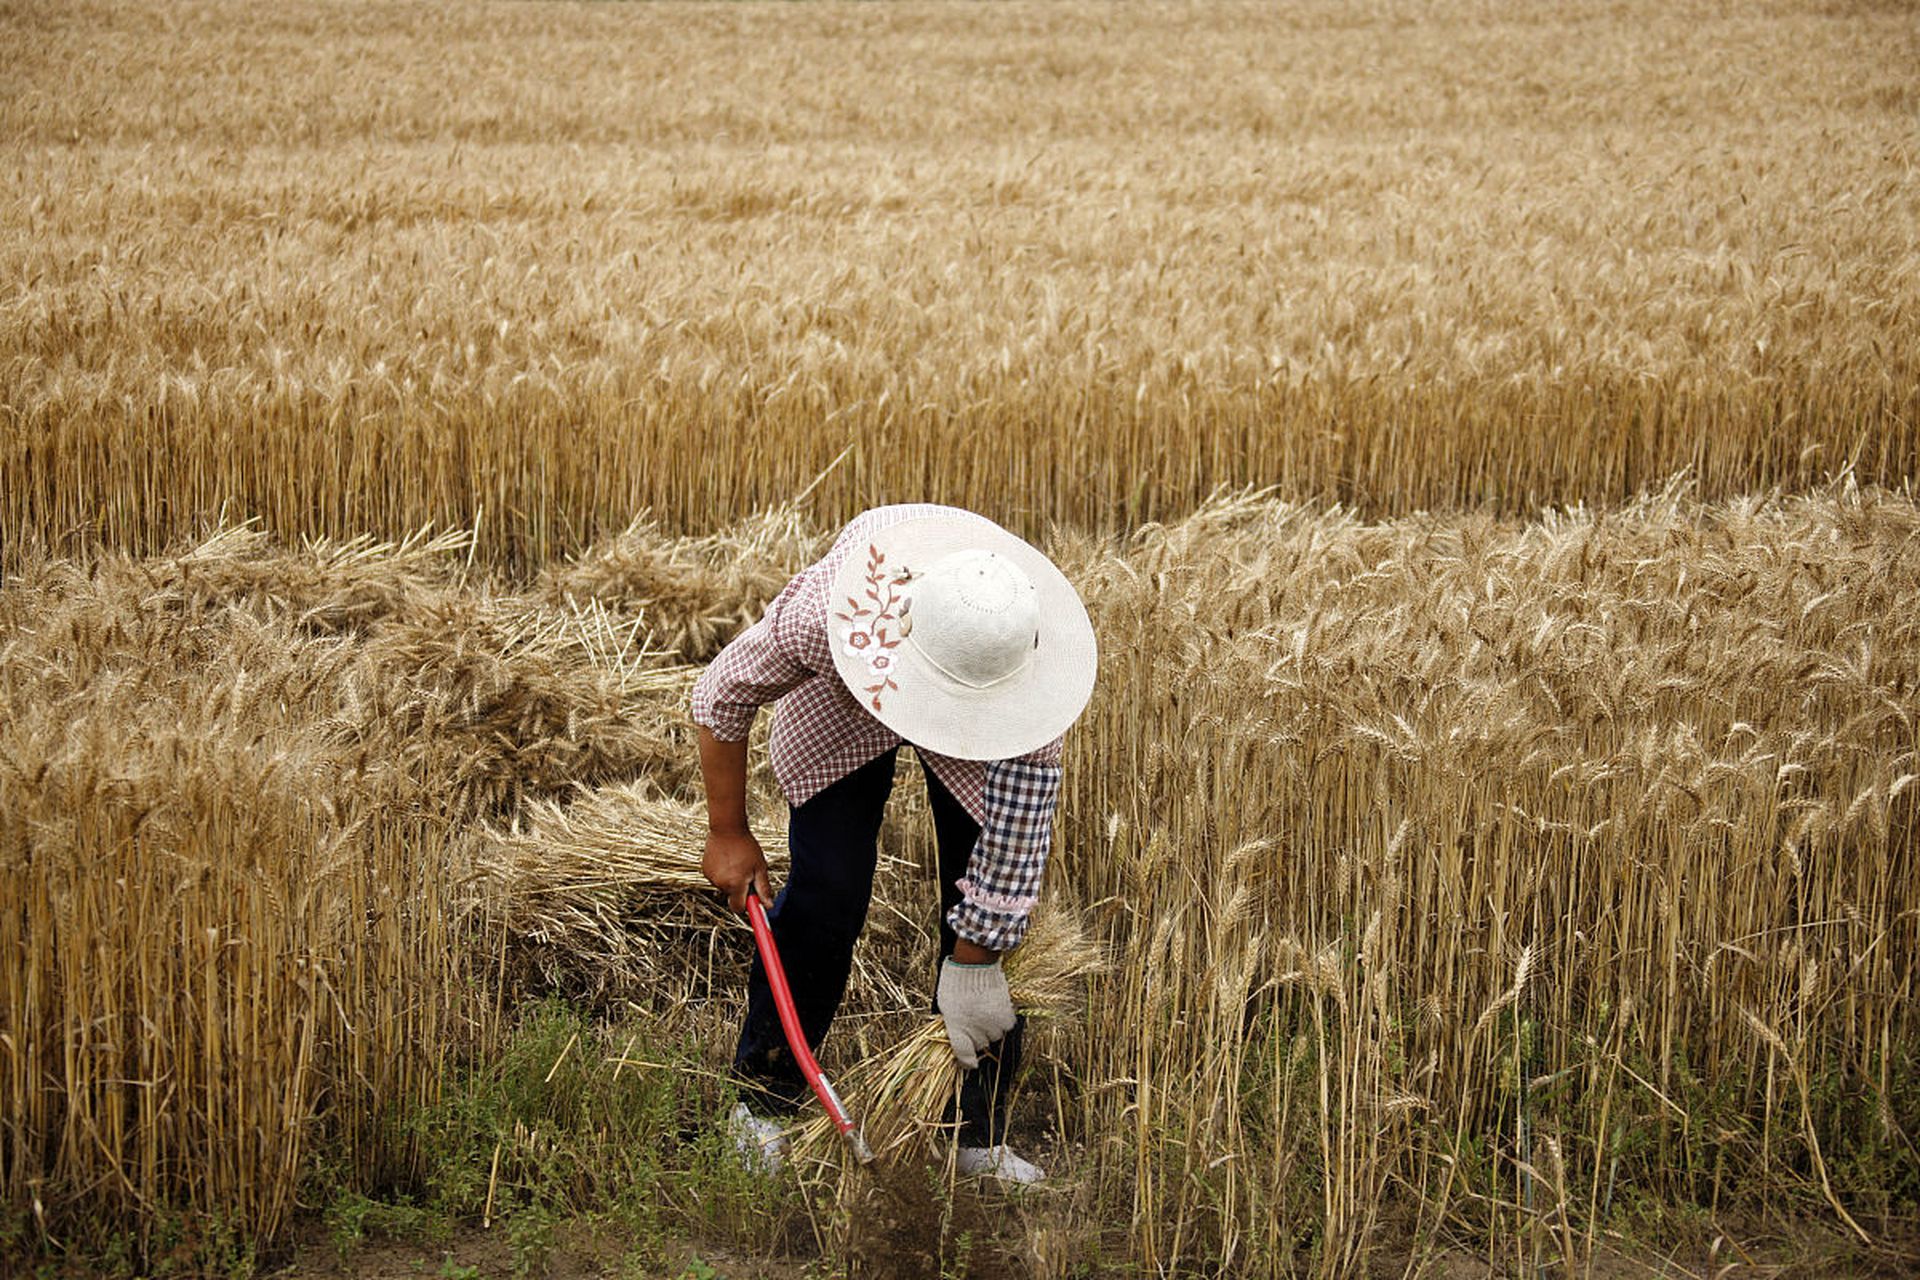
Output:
[{"xmin": 693, "ymin": 503, "xmax": 1062, "ymax": 952}]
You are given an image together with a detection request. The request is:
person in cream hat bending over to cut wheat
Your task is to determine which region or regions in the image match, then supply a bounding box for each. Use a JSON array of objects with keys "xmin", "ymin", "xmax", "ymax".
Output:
[{"xmin": 693, "ymin": 505, "xmax": 1094, "ymax": 1182}]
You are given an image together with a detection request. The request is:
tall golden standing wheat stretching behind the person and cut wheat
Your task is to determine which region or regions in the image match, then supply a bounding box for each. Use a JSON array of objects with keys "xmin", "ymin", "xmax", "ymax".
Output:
[{"xmin": 0, "ymin": 2, "xmax": 1920, "ymax": 558}]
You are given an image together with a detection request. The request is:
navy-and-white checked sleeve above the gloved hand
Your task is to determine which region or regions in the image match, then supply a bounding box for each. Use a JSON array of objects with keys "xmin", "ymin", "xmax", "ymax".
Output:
[{"xmin": 947, "ymin": 758, "xmax": 1060, "ymax": 952}]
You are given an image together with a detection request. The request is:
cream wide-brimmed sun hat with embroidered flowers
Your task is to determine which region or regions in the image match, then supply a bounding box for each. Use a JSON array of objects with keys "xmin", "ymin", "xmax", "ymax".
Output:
[{"xmin": 828, "ymin": 510, "xmax": 1098, "ymax": 760}]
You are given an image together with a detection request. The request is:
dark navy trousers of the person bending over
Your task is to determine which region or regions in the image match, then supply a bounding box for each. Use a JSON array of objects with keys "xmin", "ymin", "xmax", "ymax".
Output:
[{"xmin": 733, "ymin": 748, "xmax": 1025, "ymax": 1146}]
